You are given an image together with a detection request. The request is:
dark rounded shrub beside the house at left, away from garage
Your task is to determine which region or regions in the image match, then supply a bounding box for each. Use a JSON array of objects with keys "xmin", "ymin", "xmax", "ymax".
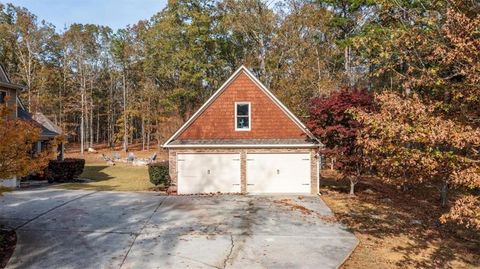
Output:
[{"xmin": 47, "ymin": 159, "xmax": 85, "ymax": 181}]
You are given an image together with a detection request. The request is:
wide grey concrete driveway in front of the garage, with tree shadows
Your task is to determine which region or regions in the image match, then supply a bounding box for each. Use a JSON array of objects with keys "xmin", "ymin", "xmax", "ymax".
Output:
[{"xmin": 0, "ymin": 189, "xmax": 357, "ymax": 269}]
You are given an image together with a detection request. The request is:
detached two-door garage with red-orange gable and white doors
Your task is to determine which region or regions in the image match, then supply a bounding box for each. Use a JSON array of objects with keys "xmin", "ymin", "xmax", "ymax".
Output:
[{"xmin": 164, "ymin": 66, "xmax": 322, "ymax": 194}]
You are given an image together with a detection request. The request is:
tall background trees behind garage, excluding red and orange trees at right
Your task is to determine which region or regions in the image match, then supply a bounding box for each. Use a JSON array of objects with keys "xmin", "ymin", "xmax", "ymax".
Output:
[{"xmin": 0, "ymin": 0, "xmax": 358, "ymax": 151}]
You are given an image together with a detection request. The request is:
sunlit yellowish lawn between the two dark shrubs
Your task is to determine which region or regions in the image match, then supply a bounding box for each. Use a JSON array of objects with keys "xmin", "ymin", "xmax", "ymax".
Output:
[{"xmin": 54, "ymin": 162, "xmax": 154, "ymax": 191}]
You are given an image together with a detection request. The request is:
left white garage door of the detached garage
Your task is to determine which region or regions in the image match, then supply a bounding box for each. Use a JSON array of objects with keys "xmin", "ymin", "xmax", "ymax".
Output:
[{"xmin": 177, "ymin": 154, "xmax": 241, "ymax": 194}]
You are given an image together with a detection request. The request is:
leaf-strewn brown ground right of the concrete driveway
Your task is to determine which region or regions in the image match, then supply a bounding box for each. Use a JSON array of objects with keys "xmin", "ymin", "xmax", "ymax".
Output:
[{"xmin": 321, "ymin": 170, "xmax": 480, "ymax": 268}]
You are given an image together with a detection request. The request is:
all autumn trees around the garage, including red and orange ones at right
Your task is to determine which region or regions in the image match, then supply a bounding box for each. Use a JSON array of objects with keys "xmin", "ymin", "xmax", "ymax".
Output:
[{"xmin": 0, "ymin": 0, "xmax": 480, "ymax": 228}]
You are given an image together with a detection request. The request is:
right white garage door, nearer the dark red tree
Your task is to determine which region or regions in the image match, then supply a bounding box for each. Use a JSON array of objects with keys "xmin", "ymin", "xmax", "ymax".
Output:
[{"xmin": 247, "ymin": 153, "xmax": 311, "ymax": 193}]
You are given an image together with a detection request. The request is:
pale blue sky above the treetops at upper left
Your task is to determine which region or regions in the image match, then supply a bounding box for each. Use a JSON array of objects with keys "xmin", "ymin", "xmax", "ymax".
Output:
[{"xmin": 4, "ymin": 0, "xmax": 166, "ymax": 31}]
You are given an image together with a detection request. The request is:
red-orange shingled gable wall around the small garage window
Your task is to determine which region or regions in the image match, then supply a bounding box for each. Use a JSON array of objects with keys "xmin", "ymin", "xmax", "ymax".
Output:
[{"xmin": 177, "ymin": 72, "xmax": 305, "ymax": 140}]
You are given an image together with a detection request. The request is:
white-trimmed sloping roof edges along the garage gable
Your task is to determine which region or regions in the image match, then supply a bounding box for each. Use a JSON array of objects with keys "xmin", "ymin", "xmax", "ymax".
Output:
[{"xmin": 163, "ymin": 65, "xmax": 321, "ymax": 148}]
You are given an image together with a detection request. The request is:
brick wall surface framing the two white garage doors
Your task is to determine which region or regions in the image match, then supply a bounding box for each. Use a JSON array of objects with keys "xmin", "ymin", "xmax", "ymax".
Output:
[{"xmin": 168, "ymin": 148, "xmax": 318, "ymax": 194}]
